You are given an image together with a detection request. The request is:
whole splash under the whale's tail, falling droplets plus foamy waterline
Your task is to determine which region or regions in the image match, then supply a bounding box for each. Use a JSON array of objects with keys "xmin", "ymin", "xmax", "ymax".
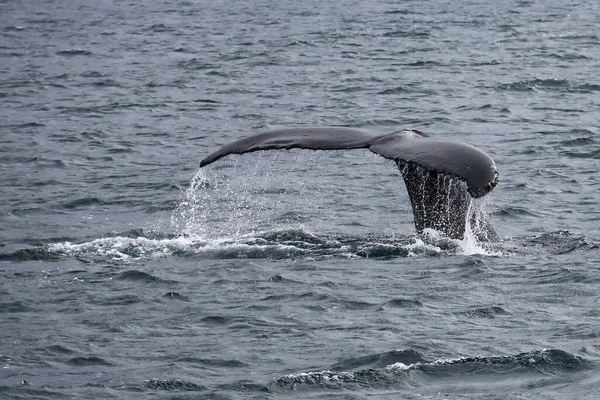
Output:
[{"xmin": 34, "ymin": 154, "xmax": 502, "ymax": 262}]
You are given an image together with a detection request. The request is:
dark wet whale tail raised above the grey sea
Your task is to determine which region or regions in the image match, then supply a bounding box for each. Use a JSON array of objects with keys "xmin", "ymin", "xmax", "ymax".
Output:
[{"xmin": 200, "ymin": 127, "xmax": 498, "ymax": 240}]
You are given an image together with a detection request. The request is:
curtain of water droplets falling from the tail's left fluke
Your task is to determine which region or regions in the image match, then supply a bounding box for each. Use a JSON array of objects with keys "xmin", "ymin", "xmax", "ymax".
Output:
[{"xmin": 171, "ymin": 155, "xmax": 310, "ymax": 239}]
